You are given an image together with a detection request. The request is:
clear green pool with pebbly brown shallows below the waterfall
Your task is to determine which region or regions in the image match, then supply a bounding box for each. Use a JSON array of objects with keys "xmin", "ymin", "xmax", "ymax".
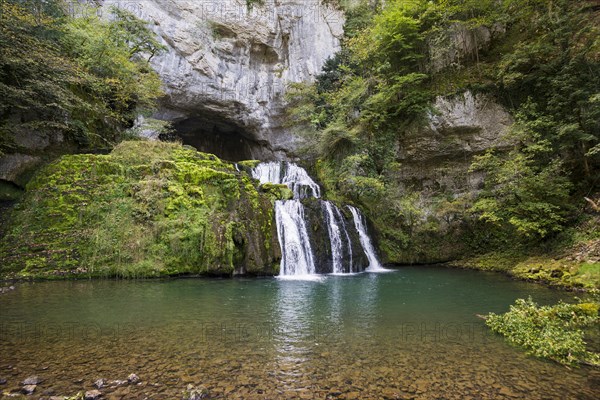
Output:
[{"xmin": 0, "ymin": 267, "xmax": 600, "ymax": 399}]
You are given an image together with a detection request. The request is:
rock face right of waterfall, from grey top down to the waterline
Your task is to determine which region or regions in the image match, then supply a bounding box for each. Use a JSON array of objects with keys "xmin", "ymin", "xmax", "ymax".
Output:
[{"xmin": 377, "ymin": 92, "xmax": 514, "ymax": 264}]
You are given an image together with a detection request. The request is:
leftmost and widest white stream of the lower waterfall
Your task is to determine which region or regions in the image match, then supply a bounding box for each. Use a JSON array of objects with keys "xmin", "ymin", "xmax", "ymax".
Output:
[{"xmin": 275, "ymin": 200, "xmax": 315, "ymax": 276}]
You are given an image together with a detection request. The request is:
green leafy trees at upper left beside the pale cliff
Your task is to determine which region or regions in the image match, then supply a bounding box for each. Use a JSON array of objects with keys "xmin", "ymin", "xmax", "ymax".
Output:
[{"xmin": 0, "ymin": 0, "xmax": 164, "ymax": 153}]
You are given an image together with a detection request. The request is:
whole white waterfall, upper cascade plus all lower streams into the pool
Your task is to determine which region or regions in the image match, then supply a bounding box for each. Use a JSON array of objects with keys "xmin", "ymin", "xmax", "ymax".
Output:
[{"xmin": 252, "ymin": 162, "xmax": 383, "ymax": 279}]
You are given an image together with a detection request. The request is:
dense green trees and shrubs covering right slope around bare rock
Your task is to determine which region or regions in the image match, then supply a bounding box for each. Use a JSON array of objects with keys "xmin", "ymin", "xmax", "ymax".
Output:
[{"xmin": 289, "ymin": 0, "xmax": 600, "ymax": 259}]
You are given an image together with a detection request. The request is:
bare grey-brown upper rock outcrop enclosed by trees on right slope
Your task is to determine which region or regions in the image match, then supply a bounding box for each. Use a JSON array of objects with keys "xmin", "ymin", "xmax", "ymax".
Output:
[{"xmin": 398, "ymin": 92, "xmax": 514, "ymax": 195}]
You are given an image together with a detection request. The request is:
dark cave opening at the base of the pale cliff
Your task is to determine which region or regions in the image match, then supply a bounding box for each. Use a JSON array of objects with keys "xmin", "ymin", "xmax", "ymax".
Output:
[{"xmin": 173, "ymin": 116, "xmax": 266, "ymax": 162}]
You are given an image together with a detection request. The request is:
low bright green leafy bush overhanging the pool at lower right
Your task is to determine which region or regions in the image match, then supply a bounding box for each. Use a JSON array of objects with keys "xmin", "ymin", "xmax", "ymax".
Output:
[{"xmin": 486, "ymin": 297, "xmax": 600, "ymax": 365}]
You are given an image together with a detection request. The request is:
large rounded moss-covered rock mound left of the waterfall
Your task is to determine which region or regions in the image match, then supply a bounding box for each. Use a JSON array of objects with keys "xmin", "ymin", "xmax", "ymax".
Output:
[{"xmin": 0, "ymin": 142, "xmax": 285, "ymax": 278}]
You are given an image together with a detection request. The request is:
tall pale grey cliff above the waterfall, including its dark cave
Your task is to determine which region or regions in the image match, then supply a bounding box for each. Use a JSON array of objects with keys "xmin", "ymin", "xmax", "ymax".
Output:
[{"xmin": 104, "ymin": 0, "xmax": 344, "ymax": 161}]
